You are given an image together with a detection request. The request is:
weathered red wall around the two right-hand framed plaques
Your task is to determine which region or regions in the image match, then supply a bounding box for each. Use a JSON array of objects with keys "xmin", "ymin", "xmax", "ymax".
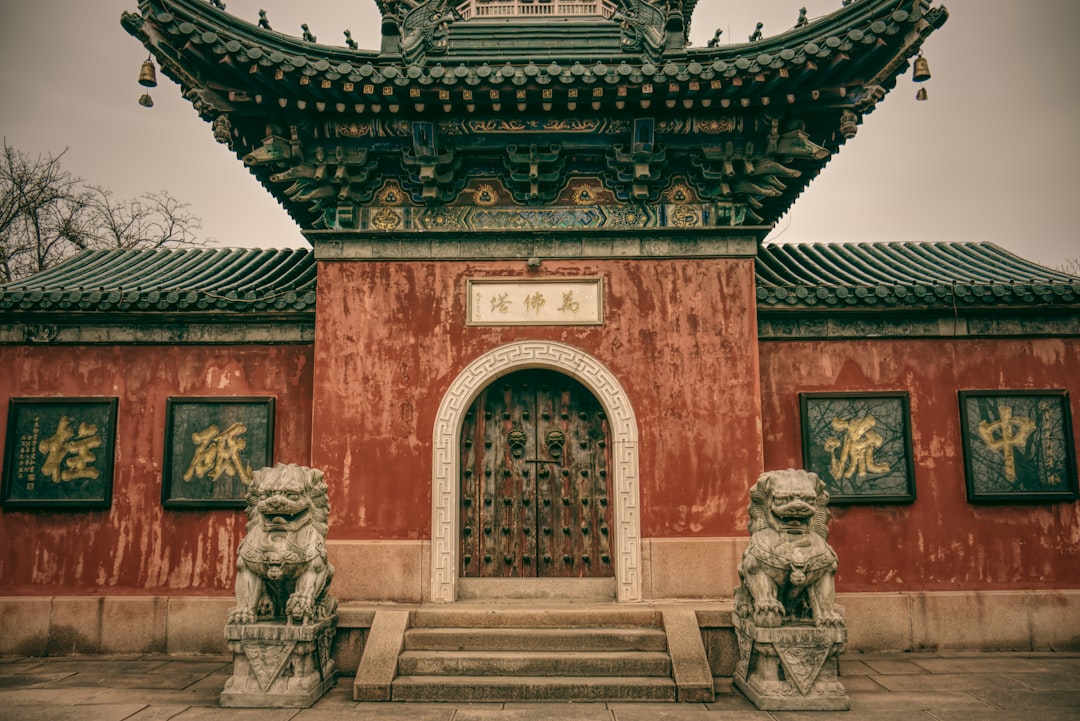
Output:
[{"xmin": 761, "ymin": 339, "xmax": 1080, "ymax": 591}]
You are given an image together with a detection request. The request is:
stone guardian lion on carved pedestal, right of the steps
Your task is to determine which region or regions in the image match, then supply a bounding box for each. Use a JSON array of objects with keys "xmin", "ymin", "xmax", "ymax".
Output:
[{"xmin": 732, "ymin": 470, "xmax": 851, "ymax": 711}]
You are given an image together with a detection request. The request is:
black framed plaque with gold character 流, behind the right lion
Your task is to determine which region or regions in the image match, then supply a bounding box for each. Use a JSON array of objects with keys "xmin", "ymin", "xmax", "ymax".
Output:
[{"xmin": 799, "ymin": 392, "xmax": 915, "ymax": 504}]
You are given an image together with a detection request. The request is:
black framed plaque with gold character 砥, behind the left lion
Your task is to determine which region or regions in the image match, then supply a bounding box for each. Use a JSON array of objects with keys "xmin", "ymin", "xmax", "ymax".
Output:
[{"xmin": 161, "ymin": 396, "xmax": 274, "ymax": 508}]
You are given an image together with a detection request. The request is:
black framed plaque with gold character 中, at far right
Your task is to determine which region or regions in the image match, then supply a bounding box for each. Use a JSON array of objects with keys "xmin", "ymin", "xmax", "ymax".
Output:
[{"xmin": 959, "ymin": 390, "xmax": 1077, "ymax": 503}]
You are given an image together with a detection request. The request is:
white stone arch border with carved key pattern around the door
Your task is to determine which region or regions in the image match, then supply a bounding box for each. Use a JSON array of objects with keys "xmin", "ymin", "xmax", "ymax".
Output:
[{"xmin": 431, "ymin": 340, "xmax": 642, "ymax": 603}]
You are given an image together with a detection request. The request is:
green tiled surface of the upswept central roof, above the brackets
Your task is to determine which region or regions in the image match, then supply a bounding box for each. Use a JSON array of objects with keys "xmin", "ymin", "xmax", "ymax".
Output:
[{"xmin": 122, "ymin": 0, "xmax": 948, "ymax": 92}]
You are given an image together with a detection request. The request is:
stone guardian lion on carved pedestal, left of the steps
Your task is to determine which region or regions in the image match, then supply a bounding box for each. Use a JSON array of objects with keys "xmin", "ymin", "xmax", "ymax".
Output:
[{"xmin": 220, "ymin": 463, "xmax": 337, "ymax": 708}]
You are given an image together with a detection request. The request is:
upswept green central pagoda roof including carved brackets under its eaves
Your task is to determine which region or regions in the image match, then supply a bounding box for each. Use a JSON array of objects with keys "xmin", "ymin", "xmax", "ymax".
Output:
[{"xmin": 122, "ymin": 0, "xmax": 948, "ymax": 236}]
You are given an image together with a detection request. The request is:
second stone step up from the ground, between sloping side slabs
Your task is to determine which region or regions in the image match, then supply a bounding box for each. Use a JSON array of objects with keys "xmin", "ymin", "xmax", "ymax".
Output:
[{"xmin": 397, "ymin": 650, "xmax": 672, "ymax": 679}]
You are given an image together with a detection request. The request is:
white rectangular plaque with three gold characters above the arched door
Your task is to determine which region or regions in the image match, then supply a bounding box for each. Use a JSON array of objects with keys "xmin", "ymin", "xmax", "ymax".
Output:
[{"xmin": 468, "ymin": 277, "xmax": 604, "ymax": 326}]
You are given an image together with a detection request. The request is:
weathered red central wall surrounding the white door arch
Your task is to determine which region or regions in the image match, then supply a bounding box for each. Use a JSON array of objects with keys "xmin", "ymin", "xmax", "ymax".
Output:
[{"xmin": 312, "ymin": 259, "xmax": 761, "ymax": 540}]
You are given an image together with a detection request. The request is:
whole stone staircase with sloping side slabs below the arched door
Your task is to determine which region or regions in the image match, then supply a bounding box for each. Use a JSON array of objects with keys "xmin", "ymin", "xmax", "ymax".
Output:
[{"xmin": 353, "ymin": 604, "xmax": 713, "ymax": 703}]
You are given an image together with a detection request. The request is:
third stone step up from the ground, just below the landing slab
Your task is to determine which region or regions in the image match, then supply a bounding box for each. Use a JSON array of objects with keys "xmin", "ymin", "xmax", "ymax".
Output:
[{"xmin": 405, "ymin": 626, "xmax": 667, "ymax": 652}]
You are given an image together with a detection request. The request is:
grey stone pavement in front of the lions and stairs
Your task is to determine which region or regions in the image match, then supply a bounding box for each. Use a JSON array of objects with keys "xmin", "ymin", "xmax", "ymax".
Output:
[{"xmin": 0, "ymin": 652, "xmax": 1080, "ymax": 721}]
